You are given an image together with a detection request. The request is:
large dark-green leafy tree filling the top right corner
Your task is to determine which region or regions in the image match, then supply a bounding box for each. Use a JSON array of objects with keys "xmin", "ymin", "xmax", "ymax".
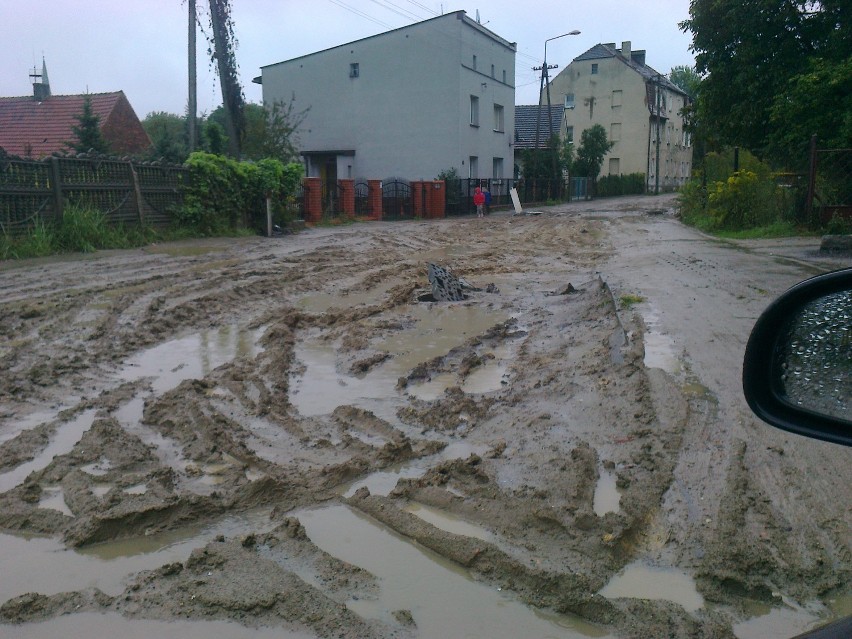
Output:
[{"xmin": 680, "ymin": 0, "xmax": 852, "ymax": 162}]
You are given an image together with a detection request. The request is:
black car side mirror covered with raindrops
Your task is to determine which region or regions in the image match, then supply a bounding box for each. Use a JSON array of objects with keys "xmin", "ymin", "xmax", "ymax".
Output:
[{"xmin": 743, "ymin": 268, "xmax": 852, "ymax": 446}]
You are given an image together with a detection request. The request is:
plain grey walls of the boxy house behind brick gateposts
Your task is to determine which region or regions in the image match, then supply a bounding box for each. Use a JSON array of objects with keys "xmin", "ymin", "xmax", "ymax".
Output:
[{"xmin": 262, "ymin": 12, "xmax": 515, "ymax": 179}]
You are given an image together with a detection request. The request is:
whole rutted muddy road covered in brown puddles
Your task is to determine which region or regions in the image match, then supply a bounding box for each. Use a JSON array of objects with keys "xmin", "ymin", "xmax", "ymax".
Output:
[{"xmin": 0, "ymin": 196, "xmax": 852, "ymax": 639}]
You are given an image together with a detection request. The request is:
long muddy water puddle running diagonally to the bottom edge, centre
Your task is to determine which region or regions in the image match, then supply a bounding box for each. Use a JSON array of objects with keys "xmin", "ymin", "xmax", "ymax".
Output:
[{"xmin": 296, "ymin": 506, "xmax": 607, "ymax": 639}]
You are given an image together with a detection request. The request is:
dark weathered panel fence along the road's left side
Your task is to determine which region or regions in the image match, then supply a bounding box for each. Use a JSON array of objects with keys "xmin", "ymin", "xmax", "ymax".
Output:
[{"xmin": 0, "ymin": 155, "xmax": 188, "ymax": 235}]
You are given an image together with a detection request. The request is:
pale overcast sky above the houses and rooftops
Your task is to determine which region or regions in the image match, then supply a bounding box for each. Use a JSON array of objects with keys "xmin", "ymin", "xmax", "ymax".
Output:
[{"xmin": 0, "ymin": 0, "xmax": 694, "ymax": 119}]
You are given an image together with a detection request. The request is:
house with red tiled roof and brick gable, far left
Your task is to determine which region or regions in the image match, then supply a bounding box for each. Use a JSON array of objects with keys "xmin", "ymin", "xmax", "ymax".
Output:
[{"xmin": 0, "ymin": 64, "xmax": 151, "ymax": 159}]
